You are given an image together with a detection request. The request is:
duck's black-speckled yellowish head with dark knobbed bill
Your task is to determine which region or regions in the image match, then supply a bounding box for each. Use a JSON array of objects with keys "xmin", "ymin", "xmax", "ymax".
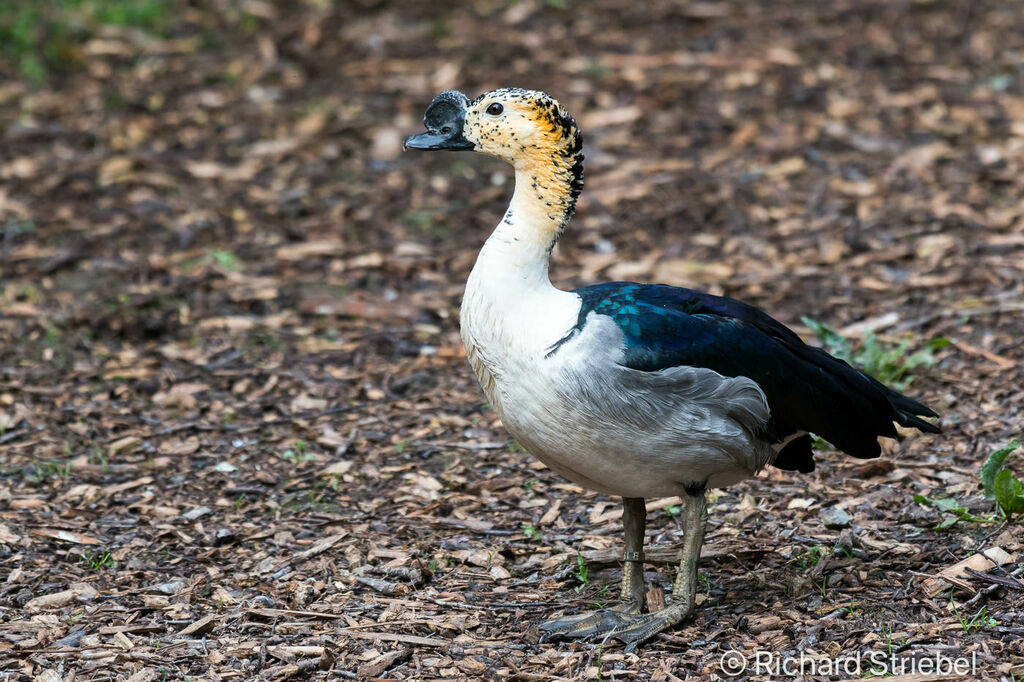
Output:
[{"xmin": 406, "ymin": 88, "xmax": 583, "ymax": 168}]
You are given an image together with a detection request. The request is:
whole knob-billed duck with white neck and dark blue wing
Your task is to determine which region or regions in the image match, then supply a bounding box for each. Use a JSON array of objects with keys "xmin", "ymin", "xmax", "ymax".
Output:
[{"xmin": 404, "ymin": 88, "xmax": 939, "ymax": 651}]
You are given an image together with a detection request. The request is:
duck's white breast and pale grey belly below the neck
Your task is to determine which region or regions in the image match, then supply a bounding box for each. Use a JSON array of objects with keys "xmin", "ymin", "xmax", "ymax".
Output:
[{"xmin": 462, "ymin": 278, "xmax": 767, "ymax": 497}]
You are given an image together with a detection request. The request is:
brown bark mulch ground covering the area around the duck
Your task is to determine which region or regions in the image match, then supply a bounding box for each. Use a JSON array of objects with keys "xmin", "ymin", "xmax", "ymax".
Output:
[{"xmin": 0, "ymin": 0, "xmax": 1024, "ymax": 682}]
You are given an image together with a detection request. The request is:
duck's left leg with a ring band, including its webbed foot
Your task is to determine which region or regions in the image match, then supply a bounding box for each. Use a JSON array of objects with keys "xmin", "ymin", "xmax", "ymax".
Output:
[{"xmin": 539, "ymin": 498, "xmax": 647, "ymax": 639}]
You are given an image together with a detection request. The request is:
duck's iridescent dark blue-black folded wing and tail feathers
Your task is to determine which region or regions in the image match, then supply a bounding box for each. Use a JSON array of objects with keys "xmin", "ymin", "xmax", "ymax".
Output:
[{"xmin": 575, "ymin": 282, "xmax": 938, "ymax": 471}]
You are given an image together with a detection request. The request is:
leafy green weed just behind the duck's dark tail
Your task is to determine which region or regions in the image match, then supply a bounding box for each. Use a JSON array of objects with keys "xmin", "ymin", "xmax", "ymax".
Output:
[{"xmin": 801, "ymin": 317, "xmax": 950, "ymax": 390}]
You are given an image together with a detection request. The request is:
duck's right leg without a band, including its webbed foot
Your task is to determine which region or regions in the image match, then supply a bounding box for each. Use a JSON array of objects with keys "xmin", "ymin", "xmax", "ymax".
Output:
[{"xmin": 610, "ymin": 487, "xmax": 708, "ymax": 651}]
